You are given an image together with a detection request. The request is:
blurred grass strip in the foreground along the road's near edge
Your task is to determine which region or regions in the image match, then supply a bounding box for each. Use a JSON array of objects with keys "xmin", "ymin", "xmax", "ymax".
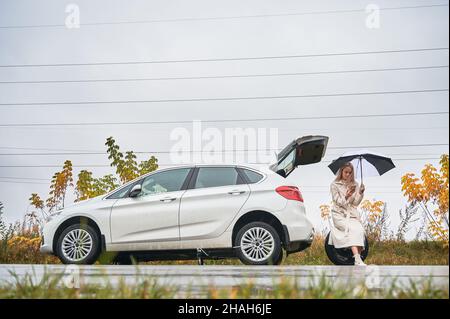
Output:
[{"xmin": 0, "ymin": 274, "xmax": 449, "ymax": 299}]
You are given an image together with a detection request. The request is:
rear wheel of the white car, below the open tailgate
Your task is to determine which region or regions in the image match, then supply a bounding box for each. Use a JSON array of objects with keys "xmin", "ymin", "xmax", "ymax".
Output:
[{"xmin": 234, "ymin": 222, "xmax": 283, "ymax": 265}]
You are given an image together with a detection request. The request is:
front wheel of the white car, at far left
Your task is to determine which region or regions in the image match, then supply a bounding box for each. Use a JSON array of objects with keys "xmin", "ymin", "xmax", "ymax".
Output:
[{"xmin": 56, "ymin": 223, "xmax": 101, "ymax": 265}]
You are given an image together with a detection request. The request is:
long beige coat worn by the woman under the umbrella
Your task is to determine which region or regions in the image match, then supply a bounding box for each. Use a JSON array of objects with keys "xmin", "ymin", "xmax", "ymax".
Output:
[{"xmin": 329, "ymin": 181, "xmax": 365, "ymax": 248}]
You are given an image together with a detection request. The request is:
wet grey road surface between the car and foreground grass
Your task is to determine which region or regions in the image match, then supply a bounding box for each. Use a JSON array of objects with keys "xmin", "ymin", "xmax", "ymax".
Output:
[{"xmin": 0, "ymin": 265, "xmax": 449, "ymax": 295}]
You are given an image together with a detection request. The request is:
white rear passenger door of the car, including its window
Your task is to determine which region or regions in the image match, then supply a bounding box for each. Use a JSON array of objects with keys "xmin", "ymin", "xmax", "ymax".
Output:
[{"xmin": 180, "ymin": 166, "xmax": 250, "ymax": 240}]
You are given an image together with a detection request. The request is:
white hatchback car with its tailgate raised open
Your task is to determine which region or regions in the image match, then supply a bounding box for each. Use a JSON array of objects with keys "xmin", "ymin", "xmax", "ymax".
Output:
[{"xmin": 41, "ymin": 136, "xmax": 328, "ymax": 265}]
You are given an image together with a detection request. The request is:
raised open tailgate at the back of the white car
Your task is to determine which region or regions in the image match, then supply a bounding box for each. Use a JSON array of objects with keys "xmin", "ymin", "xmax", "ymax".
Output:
[{"xmin": 270, "ymin": 135, "xmax": 328, "ymax": 177}]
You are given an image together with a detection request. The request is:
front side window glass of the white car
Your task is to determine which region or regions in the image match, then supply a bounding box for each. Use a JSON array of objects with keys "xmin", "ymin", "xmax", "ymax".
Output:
[{"xmin": 139, "ymin": 168, "xmax": 190, "ymax": 196}]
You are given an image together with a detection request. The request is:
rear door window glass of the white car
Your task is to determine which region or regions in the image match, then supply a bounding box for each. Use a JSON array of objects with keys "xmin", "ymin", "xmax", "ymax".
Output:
[{"xmin": 194, "ymin": 167, "xmax": 243, "ymax": 188}]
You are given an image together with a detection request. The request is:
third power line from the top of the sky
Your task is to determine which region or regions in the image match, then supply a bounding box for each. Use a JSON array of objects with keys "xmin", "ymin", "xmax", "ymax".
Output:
[{"xmin": 0, "ymin": 65, "xmax": 449, "ymax": 84}]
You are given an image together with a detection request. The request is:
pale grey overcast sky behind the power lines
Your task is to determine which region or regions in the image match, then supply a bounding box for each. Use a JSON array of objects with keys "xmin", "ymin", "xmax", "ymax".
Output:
[{"xmin": 0, "ymin": 0, "xmax": 449, "ymax": 240}]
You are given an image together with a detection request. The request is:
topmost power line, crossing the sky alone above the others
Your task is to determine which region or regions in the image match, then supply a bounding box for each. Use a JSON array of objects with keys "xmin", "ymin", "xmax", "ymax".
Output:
[{"xmin": 0, "ymin": 4, "xmax": 448, "ymax": 29}]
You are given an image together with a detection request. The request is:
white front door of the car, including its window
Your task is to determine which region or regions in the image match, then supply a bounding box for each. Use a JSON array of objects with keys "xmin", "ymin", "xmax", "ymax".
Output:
[{"xmin": 111, "ymin": 168, "xmax": 191, "ymax": 243}]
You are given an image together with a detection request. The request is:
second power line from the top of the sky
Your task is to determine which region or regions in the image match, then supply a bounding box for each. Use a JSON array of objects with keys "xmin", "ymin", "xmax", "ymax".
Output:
[{"xmin": 0, "ymin": 47, "xmax": 448, "ymax": 68}]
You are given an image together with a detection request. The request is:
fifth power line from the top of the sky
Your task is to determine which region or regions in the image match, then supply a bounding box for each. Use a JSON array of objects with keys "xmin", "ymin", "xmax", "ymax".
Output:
[{"xmin": 0, "ymin": 110, "xmax": 449, "ymax": 127}]
